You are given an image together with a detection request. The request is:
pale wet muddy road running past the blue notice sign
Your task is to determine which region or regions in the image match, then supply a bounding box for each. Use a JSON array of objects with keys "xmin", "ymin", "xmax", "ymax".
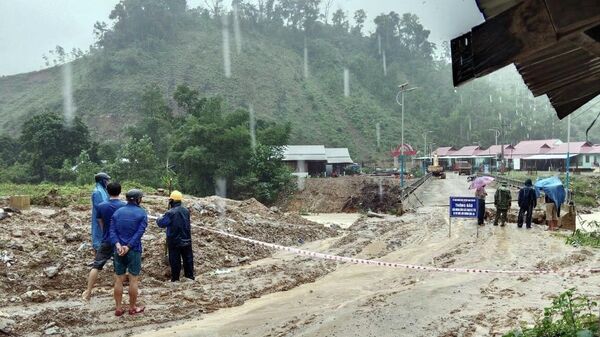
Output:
[{"xmin": 139, "ymin": 175, "xmax": 600, "ymax": 337}]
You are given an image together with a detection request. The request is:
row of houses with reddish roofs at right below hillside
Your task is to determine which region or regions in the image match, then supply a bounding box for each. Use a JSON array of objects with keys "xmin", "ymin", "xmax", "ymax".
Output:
[{"xmin": 428, "ymin": 139, "xmax": 600, "ymax": 171}]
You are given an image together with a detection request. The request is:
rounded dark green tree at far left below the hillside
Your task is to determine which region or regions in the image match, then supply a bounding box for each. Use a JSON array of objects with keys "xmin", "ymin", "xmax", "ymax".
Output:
[{"xmin": 20, "ymin": 112, "xmax": 90, "ymax": 181}]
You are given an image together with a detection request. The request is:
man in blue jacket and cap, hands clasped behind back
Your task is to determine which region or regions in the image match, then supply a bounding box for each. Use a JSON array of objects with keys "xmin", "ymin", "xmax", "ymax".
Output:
[{"xmin": 110, "ymin": 189, "xmax": 148, "ymax": 316}]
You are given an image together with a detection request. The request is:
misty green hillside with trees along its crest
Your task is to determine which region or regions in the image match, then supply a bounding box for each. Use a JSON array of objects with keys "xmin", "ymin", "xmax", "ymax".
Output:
[{"xmin": 0, "ymin": 0, "xmax": 592, "ymax": 160}]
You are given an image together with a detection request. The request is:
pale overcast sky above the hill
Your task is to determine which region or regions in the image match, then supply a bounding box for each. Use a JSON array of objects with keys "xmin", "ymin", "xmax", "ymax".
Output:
[{"xmin": 0, "ymin": 0, "xmax": 483, "ymax": 75}]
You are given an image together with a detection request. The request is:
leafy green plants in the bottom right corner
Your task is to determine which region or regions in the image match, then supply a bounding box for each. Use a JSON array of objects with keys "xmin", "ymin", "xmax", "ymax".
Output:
[{"xmin": 503, "ymin": 288, "xmax": 598, "ymax": 337}]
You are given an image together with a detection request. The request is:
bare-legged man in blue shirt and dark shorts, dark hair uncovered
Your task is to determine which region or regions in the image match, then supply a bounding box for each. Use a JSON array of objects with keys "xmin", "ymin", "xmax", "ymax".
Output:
[{"xmin": 81, "ymin": 182, "xmax": 125, "ymax": 301}]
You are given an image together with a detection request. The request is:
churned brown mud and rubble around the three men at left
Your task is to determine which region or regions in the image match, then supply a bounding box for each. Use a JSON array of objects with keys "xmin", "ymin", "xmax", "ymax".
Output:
[{"xmin": 0, "ymin": 196, "xmax": 337, "ymax": 336}]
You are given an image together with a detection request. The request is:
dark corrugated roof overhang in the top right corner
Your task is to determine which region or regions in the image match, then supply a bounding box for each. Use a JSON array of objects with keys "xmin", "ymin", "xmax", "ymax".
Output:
[{"xmin": 451, "ymin": 0, "xmax": 600, "ymax": 119}]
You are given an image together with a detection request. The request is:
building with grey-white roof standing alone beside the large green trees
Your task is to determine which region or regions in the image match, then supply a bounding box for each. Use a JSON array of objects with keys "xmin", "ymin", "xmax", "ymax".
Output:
[{"xmin": 283, "ymin": 145, "xmax": 354, "ymax": 176}]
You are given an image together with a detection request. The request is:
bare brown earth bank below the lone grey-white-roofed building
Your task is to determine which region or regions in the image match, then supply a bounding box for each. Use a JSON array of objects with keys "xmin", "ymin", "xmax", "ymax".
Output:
[{"xmin": 282, "ymin": 176, "xmax": 400, "ymax": 213}]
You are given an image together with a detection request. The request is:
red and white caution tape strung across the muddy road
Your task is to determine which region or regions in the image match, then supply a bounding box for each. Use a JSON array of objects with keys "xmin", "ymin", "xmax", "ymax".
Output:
[{"xmin": 199, "ymin": 226, "xmax": 600, "ymax": 275}]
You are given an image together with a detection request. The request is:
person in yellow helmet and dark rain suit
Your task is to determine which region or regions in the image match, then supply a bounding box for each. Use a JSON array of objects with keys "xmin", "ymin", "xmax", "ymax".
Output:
[{"xmin": 156, "ymin": 191, "xmax": 194, "ymax": 282}]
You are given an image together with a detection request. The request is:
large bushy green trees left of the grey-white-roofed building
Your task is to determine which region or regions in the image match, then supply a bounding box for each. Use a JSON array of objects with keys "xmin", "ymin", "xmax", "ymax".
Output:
[{"xmin": 172, "ymin": 86, "xmax": 290, "ymax": 201}]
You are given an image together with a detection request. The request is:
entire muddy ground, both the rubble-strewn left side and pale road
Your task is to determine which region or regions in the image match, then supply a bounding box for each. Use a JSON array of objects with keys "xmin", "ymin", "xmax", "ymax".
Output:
[{"xmin": 0, "ymin": 175, "xmax": 600, "ymax": 337}]
